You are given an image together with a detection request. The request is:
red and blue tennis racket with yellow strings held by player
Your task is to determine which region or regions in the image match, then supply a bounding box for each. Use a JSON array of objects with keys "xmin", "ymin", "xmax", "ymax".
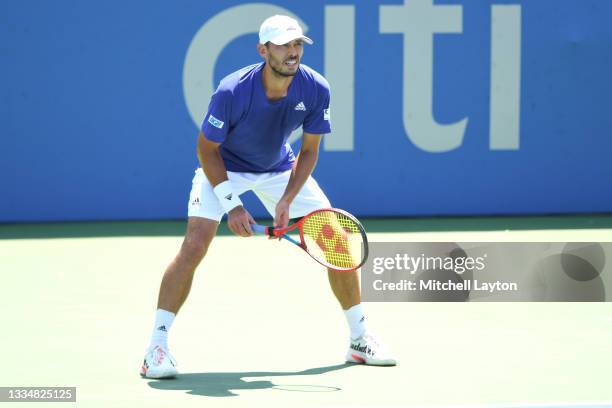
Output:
[{"xmin": 251, "ymin": 208, "xmax": 368, "ymax": 272}]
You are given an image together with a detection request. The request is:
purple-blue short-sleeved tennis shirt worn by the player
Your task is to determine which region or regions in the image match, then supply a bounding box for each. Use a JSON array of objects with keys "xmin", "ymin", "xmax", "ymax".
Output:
[{"xmin": 202, "ymin": 63, "xmax": 331, "ymax": 173}]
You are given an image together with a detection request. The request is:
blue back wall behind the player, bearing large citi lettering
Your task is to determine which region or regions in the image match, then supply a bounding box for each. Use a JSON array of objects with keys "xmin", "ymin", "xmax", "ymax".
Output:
[{"xmin": 0, "ymin": 0, "xmax": 612, "ymax": 222}]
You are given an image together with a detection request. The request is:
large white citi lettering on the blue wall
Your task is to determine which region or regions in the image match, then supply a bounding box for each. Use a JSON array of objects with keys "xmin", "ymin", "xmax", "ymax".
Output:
[{"xmin": 183, "ymin": 0, "xmax": 526, "ymax": 153}]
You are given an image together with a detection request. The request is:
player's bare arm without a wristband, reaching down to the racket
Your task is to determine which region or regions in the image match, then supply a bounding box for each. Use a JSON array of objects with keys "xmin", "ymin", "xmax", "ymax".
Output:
[{"xmin": 274, "ymin": 132, "xmax": 321, "ymax": 228}]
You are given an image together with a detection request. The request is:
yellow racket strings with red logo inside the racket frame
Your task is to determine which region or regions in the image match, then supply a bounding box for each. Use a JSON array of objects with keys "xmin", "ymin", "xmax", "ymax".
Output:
[{"xmin": 302, "ymin": 211, "xmax": 363, "ymax": 269}]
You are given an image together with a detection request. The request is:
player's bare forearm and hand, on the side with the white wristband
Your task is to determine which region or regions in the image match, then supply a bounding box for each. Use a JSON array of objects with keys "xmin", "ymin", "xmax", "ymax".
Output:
[{"xmin": 197, "ymin": 132, "xmax": 255, "ymax": 237}]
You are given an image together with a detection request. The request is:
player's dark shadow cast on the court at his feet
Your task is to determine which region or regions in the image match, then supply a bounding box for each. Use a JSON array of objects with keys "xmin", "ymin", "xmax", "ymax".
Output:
[{"xmin": 149, "ymin": 363, "xmax": 355, "ymax": 397}]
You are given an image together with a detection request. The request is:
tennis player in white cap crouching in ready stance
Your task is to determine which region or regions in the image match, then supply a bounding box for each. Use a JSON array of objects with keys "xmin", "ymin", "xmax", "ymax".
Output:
[{"xmin": 140, "ymin": 15, "xmax": 396, "ymax": 378}]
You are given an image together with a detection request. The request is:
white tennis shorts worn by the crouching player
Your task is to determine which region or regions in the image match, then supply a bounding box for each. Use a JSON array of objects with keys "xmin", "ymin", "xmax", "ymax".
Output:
[{"xmin": 188, "ymin": 168, "xmax": 331, "ymax": 221}]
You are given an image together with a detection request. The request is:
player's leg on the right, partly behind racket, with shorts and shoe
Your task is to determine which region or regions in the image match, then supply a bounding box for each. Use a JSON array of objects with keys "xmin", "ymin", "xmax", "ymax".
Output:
[{"xmin": 254, "ymin": 171, "xmax": 395, "ymax": 365}]
